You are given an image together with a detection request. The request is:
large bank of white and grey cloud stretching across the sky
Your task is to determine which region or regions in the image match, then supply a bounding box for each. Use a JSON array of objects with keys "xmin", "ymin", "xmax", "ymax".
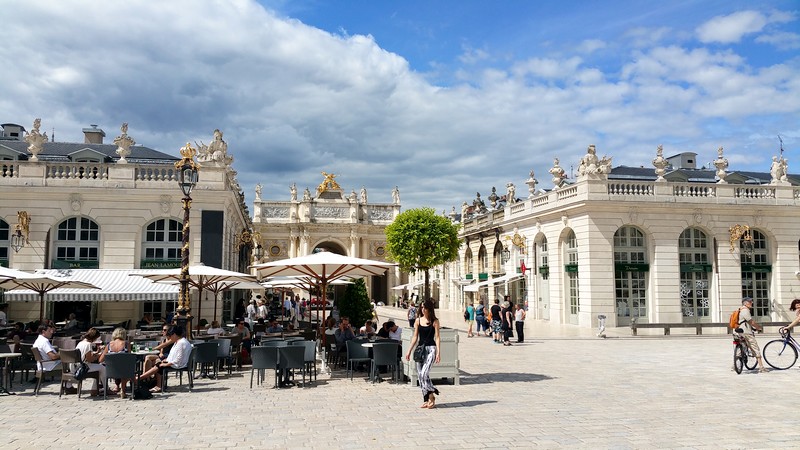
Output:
[{"xmin": 0, "ymin": 0, "xmax": 800, "ymax": 211}]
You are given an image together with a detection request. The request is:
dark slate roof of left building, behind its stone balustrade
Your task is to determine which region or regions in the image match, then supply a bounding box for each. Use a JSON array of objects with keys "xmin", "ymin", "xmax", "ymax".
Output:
[{"xmin": 0, "ymin": 141, "xmax": 180, "ymax": 163}]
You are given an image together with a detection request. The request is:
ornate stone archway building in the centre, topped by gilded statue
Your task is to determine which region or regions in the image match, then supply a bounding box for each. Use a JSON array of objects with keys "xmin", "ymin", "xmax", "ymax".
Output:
[{"xmin": 253, "ymin": 172, "xmax": 400, "ymax": 302}]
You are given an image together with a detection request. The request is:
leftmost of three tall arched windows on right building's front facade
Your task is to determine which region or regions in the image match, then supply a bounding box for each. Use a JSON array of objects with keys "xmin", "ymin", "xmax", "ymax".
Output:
[{"xmin": 614, "ymin": 226, "xmax": 649, "ymax": 325}]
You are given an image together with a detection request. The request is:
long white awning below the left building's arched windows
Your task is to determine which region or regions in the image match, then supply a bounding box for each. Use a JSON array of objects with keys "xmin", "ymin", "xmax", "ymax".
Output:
[{"xmin": 3, "ymin": 269, "xmax": 179, "ymax": 302}]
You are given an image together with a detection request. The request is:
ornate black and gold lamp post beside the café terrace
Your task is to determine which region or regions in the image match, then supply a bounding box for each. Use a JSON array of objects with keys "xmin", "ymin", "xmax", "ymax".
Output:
[{"xmin": 175, "ymin": 142, "xmax": 199, "ymax": 338}]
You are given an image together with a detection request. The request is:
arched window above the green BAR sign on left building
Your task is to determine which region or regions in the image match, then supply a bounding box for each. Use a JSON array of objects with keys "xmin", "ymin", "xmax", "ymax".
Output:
[{"xmin": 53, "ymin": 217, "xmax": 100, "ymax": 269}]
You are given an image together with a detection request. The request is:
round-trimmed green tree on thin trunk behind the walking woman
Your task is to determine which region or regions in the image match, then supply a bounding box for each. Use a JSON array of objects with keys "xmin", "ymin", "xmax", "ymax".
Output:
[{"xmin": 386, "ymin": 208, "xmax": 460, "ymax": 306}]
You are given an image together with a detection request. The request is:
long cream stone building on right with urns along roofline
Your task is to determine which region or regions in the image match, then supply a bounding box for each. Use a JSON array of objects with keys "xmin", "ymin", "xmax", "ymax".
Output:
[{"xmin": 428, "ymin": 146, "xmax": 800, "ymax": 327}]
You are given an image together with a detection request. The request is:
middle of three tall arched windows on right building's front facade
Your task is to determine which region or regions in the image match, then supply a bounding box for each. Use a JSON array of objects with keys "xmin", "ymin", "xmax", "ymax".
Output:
[{"xmin": 678, "ymin": 228, "xmax": 712, "ymax": 322}]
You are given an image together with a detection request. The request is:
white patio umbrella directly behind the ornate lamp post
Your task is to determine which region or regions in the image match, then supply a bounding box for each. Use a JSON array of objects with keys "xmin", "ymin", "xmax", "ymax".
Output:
[{"xmin": 130, "ymin": 264, "xmax": 262, "ymax": 327}]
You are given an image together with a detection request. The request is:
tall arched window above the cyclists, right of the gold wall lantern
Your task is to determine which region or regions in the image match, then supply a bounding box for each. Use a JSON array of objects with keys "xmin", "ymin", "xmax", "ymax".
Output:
[{"xmin": 740, "ymin": 230, "xmax": 772, "ymax": 318}]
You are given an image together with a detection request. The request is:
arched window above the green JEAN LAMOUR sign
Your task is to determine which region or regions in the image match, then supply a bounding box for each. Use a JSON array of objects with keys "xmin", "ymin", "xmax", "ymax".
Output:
[{"xmin": 141, "ymin": 219, "xmax": 183, "ymax": 269}]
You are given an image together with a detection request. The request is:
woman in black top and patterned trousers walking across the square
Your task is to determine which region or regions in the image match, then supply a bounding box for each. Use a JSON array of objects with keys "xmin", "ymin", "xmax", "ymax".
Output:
[{"xmin": 406, "ymin": 300, "xmax": 440, "ymax": 409}]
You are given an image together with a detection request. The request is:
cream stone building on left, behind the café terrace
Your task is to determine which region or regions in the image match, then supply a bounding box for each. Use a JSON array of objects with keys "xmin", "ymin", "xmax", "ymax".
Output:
[{"xmin": 0, "ymin": 119, "xmax": 251, "ymax": 323}]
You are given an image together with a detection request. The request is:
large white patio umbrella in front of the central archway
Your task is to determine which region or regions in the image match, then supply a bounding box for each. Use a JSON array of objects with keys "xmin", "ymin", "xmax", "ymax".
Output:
[{"xmin": 251, "ymin": 251, "xmax": 395, "ymax": 321}]
